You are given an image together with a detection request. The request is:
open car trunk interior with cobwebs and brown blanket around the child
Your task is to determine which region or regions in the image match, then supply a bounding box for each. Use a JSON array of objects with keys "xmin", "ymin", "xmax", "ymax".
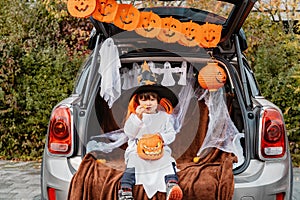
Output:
[{"xmin": 69, "ymin": 45, "xmax": 245, "ymax": 200}]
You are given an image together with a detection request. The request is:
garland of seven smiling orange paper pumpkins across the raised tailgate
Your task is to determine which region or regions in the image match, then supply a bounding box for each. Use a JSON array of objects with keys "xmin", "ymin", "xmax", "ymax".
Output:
[{"xmin": 67, "ymin": 0, "xmax": 222, "ymax": 48}]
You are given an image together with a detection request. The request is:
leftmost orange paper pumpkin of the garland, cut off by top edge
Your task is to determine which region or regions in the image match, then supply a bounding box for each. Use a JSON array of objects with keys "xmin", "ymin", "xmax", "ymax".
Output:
[{"xmin": 67, "ymin": 0, "xmax": 96, "ymax": 18}]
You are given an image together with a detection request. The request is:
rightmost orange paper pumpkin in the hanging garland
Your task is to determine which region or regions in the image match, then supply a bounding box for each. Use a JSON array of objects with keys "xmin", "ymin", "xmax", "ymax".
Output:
[{"xmin": 199, "ymin": 23, "xmax": 222, "ymax": 48}]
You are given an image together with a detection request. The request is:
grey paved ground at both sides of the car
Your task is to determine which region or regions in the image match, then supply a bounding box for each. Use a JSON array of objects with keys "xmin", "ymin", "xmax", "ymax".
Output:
[{"xmin": 0, "ymin": 160, "xmax": 300, "ymax": 200}]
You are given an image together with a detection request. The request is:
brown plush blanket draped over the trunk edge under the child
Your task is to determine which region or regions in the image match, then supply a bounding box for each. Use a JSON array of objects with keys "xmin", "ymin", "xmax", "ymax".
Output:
[{"xmin": 68, "ymin": 99, "xmax": 236, "ymax": 200}]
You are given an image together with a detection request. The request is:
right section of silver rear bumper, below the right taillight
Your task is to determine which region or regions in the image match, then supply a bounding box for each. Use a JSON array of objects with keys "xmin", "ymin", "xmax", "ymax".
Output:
[{"xmin": 233, "ymin": 158, "xmax": 292, "ymax": 200}]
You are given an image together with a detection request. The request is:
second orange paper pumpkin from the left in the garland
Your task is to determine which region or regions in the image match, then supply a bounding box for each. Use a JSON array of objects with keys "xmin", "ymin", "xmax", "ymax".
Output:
[{"xmin": 93, "ymin": 0, "xmax": 118, "ymax": 23}]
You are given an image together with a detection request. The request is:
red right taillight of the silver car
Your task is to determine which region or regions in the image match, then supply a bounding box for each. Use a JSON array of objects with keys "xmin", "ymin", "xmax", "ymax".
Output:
[{"xmin": 260, "ymin": 108, "xmax": 286, "ymax": 158}]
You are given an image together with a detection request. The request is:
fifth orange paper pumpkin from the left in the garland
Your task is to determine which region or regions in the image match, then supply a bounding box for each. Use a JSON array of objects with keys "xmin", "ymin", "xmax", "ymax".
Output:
[{"xmin": 156, "ymin": 17, "xmax": 182, "ymax": 43}]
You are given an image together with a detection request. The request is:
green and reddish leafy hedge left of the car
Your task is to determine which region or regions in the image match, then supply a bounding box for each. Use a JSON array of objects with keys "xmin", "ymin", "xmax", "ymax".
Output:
[{"xmin": 0, "ymin": 0, "xmax": 90, "ymax": 159}]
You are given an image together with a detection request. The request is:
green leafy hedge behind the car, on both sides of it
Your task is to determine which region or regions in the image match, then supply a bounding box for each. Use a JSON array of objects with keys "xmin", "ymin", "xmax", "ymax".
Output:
[{"xmin": 0, "ymin": 0, "xmax": 300, "ymax": 165}]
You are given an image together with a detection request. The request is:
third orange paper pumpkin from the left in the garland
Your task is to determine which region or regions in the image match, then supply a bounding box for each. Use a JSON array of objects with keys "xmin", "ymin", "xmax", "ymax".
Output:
[{"xmin": 114, "ymin": 4, "xmax": 140, "ymax": 31}]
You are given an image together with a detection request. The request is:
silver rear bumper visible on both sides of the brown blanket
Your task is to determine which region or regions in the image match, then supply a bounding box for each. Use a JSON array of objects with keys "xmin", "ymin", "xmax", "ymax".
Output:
[{"xmin": 42, "ymin": 155, "xmax": 292, "ymax": 200}]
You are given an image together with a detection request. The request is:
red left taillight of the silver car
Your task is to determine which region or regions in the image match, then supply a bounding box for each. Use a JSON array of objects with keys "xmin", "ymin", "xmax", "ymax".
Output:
[{"xmin": 48, "ymin": 106, "xmax": 72, "ymax": 155}]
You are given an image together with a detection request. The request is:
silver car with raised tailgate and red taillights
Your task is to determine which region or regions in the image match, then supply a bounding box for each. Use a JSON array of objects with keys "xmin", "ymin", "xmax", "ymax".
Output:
[{"xmin": 41, "ymin": 0, "xmax": 293, "ymax": 200}]
